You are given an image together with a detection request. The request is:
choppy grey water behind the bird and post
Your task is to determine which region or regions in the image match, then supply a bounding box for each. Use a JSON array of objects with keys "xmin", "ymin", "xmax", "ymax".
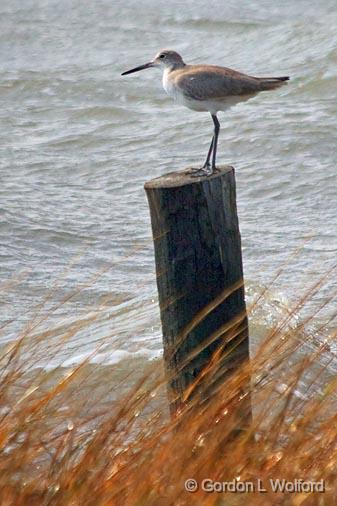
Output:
[{"xmin": 0, "ymin": 0, "xmax": 337, "ymax": 361}]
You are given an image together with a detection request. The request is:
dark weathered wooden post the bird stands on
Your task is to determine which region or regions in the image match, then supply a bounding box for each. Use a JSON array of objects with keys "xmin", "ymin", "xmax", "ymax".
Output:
[{"xmin": 145, "ymin": 167, "xmax": 250, "ymax": 420}]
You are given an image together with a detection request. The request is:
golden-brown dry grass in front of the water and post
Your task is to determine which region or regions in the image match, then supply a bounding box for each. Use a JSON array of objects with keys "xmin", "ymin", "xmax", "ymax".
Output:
[{"xmin": 0, "ymin": 266, "xmax": 337, "ymax": 506}]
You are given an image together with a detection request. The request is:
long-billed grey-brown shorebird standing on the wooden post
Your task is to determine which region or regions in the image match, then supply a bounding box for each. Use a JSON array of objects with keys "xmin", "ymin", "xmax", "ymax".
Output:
[{"xmin": 122, "ymin": 49, "xmax": 289, "ymax": 177}]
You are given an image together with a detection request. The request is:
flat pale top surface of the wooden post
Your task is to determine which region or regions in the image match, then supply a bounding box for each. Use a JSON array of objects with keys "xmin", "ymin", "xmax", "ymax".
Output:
[{"xmin": 144, "ymin": 165, "xmax": 234, "ymax": 190}]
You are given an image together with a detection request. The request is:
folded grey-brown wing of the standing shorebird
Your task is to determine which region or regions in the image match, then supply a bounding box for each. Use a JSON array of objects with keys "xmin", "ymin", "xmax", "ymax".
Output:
[{"xmin": 176, "ymin": 65, "xmax": 286, "ymax": 100}]
